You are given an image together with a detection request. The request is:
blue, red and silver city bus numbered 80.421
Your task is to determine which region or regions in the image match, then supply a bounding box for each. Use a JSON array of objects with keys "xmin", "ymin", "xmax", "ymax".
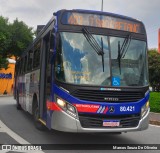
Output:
[{"xmin": 15, "ymin": 9, "xmax": 150, "ymax": 133}]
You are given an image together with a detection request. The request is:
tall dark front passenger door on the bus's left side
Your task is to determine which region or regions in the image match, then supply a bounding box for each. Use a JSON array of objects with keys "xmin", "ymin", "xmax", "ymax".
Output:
[{"xmin": 40, "ymin": 29, "xmax": 53, "ymax": 118}]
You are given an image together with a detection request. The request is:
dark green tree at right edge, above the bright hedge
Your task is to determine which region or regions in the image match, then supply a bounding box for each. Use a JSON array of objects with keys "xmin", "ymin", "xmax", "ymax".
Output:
[{"xmin": 148, "ymin": 49, "xmax": 160, "ymax": 91}]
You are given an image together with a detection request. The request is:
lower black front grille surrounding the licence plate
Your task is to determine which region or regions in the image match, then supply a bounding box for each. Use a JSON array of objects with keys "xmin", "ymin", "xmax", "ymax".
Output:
[{"xmin": 79, "ymin": 114, "xmax": 140, "ymax": 128}]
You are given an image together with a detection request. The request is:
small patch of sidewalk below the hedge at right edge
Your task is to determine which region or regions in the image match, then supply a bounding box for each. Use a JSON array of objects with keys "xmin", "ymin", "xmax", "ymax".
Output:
[{"xmin": 149, "ymin": 112, "xmax": 160, "ymax": 126}]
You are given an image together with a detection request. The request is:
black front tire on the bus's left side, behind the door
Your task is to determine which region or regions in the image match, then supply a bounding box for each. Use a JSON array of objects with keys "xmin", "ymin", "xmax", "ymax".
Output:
[{"xmin": 33, "ymin": 104, "xmax": 46, "ymax": 131}]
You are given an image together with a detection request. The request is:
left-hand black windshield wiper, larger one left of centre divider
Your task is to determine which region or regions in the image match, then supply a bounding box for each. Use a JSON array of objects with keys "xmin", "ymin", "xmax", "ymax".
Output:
[{"xmin": 82, "ymin": 27, "xmax": 104, "ymax": 72}]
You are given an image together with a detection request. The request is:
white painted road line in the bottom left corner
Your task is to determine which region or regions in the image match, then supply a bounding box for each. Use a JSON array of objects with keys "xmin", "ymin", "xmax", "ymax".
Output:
[{"xmin": 0, "ymin": 120, "xmax": 44, "ymax": 153}]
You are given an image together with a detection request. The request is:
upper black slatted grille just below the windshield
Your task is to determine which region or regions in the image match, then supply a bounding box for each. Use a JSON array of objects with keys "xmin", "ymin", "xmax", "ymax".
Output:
[{"xmin": 71, "ymin": 89, "xmax": 144, "ymax": 103}]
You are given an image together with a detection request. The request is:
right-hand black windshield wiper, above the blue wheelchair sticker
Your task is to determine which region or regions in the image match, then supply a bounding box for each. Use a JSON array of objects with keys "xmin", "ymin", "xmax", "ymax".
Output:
[{"xmin": 117, "ymin": 34, "xmax": 131, "ymax": 74}]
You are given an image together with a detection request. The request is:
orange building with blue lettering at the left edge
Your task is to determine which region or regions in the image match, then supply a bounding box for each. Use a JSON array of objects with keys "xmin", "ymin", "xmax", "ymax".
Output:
[{"xmin": 0, "ymin": 57, "xmax": 16, "ymax": 94}]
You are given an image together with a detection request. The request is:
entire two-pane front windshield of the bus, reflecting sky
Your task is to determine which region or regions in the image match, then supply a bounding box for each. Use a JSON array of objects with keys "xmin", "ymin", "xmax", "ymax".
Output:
[{"xmin": 55, "ymin": 32, "xmax": 148, "ymax": 86}]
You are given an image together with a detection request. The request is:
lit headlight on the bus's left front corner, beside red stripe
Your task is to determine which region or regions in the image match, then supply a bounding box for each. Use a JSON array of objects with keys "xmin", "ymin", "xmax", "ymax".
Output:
[{"xmin": 57, "ymin": 98, "xmax": 77, "ymax": 117}]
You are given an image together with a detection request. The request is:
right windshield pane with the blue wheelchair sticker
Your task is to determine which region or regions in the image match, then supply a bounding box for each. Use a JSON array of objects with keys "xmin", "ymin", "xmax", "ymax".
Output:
[{"xmin": 110, "ymin": 37, "xmax": 148, "ymax": 86}]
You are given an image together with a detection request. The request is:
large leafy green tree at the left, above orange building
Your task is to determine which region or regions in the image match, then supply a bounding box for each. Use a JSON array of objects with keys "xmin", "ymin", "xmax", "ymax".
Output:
[{"xmin": 0, "ymin": 16, "xmax": 34, "ymax": 69}]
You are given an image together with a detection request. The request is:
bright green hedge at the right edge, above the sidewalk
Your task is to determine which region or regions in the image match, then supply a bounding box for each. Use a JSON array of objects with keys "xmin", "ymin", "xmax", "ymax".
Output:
[{"xmin": 149, "ymin": 92, "xmax": 160, "ymax": 113}]
